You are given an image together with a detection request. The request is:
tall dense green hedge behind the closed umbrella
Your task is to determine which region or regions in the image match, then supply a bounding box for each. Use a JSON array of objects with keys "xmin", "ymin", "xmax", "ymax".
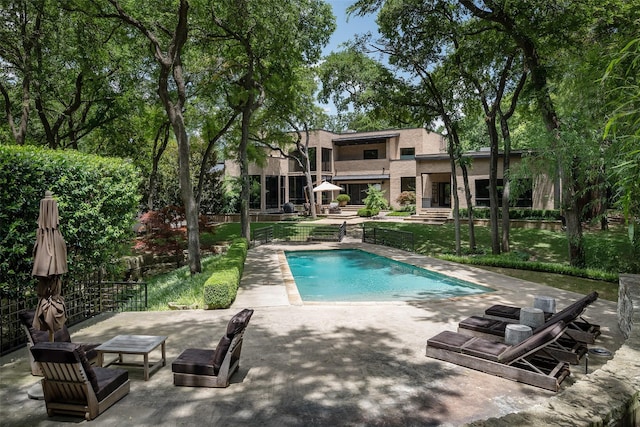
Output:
[{"xmin": 0, "ymin": 145, "xmax": 140, "ymax": 297}]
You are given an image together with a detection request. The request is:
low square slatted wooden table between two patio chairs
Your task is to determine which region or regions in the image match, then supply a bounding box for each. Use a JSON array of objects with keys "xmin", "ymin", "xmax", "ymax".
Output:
[{"xmin": 96, "ymin": 335, "xmax": 167, "ymax": 381}]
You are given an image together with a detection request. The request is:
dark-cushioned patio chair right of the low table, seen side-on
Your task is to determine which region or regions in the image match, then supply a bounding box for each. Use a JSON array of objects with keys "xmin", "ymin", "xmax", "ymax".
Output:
[{"xmin": 171, "ymin": 309, "xmax": 253, "ymax": 387}]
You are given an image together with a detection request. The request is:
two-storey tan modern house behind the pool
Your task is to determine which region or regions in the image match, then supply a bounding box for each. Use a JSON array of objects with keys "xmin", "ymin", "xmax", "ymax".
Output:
[{"xmin": 225, "ymin": 128, "xmax": 554, "ymax": 215}]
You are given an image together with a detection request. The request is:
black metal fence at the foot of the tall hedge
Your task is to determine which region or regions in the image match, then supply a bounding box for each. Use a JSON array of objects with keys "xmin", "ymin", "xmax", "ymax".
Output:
[{"xmin": 0, "ymin": 279, "xmax": 148, "ymax": 356}]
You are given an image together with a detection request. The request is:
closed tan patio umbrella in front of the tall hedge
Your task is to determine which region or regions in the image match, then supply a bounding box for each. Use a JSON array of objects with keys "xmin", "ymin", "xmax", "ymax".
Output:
[{"xmin": 31, "ymin": 191, "xmax": 68, "ymax": 341}]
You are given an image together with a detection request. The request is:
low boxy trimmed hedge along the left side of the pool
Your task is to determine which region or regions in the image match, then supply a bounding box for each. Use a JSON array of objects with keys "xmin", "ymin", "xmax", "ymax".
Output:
[{"xmin": 204, "ymin": 238, "xmax": 249, "ymax": 309}]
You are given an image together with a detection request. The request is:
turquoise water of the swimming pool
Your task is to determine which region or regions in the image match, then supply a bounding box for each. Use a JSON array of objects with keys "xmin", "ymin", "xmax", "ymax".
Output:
[{"xmin": 285, "ymin": 249, "xmax": 492, "ymax": 301}]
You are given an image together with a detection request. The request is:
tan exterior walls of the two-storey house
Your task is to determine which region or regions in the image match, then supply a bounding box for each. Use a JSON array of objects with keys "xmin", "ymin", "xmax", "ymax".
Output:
[{"xmin": 225, "ymin": 128, "xmax": 554, "ymax": 213}]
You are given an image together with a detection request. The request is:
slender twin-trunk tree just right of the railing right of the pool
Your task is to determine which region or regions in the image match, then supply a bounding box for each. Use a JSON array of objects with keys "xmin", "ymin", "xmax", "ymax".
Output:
[{"xmin": 352, "ymin": 0, "xmax": 475, "ymax": 254}]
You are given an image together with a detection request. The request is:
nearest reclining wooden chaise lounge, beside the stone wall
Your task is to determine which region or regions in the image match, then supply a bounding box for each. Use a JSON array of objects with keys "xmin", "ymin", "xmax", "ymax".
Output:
[{"xmin": 426, "ymin": 321, "xmax": 570, "ymax": 391}]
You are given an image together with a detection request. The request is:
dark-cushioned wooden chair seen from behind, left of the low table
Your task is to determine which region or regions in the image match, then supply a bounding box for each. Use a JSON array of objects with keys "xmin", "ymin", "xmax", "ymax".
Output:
[{"xmin": 30, "ymin": 342, "xmax": 130, "ymax": 420}]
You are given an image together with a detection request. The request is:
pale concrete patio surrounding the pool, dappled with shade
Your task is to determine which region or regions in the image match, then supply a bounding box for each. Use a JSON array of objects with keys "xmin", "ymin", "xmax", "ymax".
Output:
[{"xmin": 0, "ymin": 239, "xmax": 622, "ymax": 426}]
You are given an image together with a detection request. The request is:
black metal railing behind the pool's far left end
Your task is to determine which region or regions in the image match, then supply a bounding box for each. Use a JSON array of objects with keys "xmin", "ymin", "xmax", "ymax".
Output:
[{"xmin": 251, "ymin": 222, "xmax": 347, "ymax": 245}]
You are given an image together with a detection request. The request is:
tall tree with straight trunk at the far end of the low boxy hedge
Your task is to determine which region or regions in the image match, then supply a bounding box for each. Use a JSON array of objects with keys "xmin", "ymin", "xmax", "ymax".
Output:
[{"xmin": 209, "ymin": 0, "xmax": 335, "ymax": 237}]
